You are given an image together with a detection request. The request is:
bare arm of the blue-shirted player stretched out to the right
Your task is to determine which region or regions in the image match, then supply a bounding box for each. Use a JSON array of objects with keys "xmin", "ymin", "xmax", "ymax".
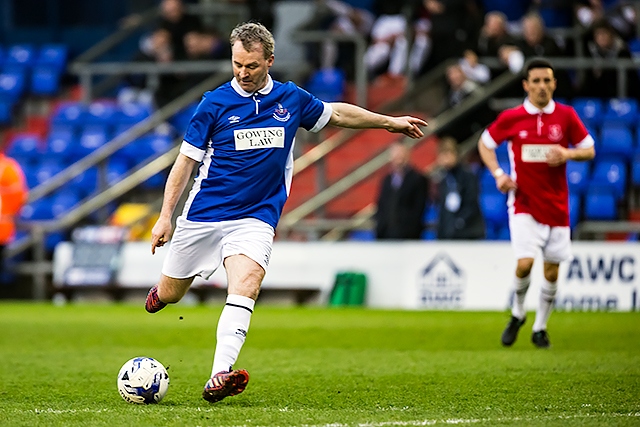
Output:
[{"xmin": 329, "ymin": 102, "xmax": 427, "ymax": 138}]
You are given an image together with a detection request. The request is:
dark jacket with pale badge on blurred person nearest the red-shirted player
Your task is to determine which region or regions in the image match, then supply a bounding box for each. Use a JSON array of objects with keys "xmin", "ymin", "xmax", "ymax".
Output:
[{"xmin": 436, "ymin": 165, "xmax": 485, "ymax": 240}]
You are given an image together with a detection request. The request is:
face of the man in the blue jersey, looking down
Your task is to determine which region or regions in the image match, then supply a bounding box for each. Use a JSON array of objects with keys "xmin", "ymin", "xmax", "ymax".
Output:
[{"xmin": 231, "ymin": 40, "xmax": 273, "ymax": 93}]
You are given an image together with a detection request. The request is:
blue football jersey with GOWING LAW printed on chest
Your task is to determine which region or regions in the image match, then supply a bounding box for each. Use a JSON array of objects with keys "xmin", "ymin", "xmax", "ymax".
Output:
[{"xmin": 180, "ymin": 76, "xmax": 332, "ymax": 228}]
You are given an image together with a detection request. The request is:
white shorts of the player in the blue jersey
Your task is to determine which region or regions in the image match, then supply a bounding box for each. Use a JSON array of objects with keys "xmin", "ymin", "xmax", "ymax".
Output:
[{"xmin": 162, "ymin": 215, "xmax": 274, "ymax": 279}]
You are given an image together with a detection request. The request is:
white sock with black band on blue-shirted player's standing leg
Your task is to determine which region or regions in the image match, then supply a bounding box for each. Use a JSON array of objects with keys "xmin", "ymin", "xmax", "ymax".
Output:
[{"xmin": 211, "ymin": 295, "xmax": 256, "ymax": 376}]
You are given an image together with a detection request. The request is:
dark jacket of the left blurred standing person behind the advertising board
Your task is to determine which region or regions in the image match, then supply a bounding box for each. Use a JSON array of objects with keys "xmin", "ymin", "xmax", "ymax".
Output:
[{"xmin": 376, "ymin": 168, "xmax": 428, "ymax": 239}]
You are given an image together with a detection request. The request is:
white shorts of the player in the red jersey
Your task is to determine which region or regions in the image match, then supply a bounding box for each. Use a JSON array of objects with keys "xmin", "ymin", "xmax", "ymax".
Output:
[{"xmin": 509, "ymin": 214, "xmax": 571, "ymax": 264}]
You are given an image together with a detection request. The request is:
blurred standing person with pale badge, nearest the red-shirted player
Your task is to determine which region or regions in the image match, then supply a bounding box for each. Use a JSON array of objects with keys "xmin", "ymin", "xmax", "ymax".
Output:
[{"xmin": 435, "ymin": 138, "xmax": 485, "ymax": 240}]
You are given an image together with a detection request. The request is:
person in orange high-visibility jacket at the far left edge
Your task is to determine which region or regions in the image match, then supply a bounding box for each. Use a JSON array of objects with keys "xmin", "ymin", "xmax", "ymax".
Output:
[{"xmin": 0, "ymin": 147, "xmax": 28, "ymax": 284}]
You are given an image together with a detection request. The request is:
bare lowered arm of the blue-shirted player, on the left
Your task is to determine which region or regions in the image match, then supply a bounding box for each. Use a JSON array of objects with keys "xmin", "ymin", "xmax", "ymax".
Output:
[{"xmin": 151, "ymin": 153, "xmax": 198, "ymax": 254}]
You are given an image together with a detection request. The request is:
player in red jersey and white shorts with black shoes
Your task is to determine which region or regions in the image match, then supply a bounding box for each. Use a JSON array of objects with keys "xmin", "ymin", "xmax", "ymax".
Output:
[{"xmin": 478, "ymin": 59, "xmax": 595, "ymax": 348}]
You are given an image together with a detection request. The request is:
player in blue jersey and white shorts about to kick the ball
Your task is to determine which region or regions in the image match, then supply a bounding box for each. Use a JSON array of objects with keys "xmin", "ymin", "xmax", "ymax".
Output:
[{"xmin": 145, "ymin": 22, "xmax": 427, "ymax": 402}]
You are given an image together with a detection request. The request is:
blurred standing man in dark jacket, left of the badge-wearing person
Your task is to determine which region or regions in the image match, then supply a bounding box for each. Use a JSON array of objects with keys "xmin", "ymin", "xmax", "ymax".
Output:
[{"xmin": 375, "ymin": 143, "xmax": 428, "ymax": 240}]
